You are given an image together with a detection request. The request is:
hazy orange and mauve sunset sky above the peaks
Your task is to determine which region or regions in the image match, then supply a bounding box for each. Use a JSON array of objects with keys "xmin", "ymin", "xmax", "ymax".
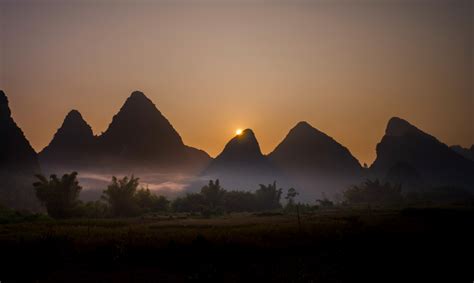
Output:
[{"xmin": 0, "ymin": 0, "xmax": 474, "ymax": 164}]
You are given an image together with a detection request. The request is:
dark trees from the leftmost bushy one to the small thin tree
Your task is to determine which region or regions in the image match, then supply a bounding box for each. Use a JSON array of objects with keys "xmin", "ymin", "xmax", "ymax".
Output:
[{"xmin": 29, "ymin": 172, "xmax": 297, "ymax": 218}]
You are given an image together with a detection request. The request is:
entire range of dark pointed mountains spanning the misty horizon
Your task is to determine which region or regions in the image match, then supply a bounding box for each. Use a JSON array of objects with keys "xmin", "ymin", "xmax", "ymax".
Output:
[{"xmin": 0, "ymin": 91, "xmax": 474, "ymax": 206}]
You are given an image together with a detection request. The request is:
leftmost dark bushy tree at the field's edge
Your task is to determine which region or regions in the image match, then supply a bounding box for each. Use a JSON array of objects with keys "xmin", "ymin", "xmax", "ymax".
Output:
[{"xmin": 33, "ymin": 172, "xmax": 82, "ymax": 218}]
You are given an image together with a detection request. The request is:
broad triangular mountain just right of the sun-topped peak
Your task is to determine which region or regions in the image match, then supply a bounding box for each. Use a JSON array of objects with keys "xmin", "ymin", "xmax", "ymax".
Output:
[{"xmin": 269, "ymin": 122, "xmax": 363, "ymax": 201}]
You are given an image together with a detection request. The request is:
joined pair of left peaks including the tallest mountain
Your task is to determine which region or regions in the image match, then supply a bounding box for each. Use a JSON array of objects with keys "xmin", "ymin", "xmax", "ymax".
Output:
[{"xmin": 39, "ymin": 91, "xmax": 210, "ymax": 174}]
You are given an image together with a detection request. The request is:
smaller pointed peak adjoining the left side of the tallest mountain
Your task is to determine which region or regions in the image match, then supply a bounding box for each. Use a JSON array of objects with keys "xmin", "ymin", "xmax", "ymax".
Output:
[{"xmin": 39, "ymin": 110, "xmax": 96, "ymax": 170}]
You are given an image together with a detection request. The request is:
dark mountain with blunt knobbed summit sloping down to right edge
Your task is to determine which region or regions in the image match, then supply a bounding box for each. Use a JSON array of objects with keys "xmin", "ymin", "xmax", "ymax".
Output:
[{"xmin": 370, "ymin": 117, "xmax": 474, "ymax": 189}]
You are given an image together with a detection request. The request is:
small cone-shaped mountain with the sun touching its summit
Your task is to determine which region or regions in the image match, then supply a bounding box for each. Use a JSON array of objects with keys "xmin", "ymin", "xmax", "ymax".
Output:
[{"xmin": 202, "ymin": 129, "xmax": 281, "ymax": 190}]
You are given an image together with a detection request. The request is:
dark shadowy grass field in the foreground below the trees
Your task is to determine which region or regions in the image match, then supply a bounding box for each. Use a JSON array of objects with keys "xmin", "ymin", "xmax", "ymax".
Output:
[{"xmin": 0, "ymin": 208, "xmax": 474, "ymax": 282}]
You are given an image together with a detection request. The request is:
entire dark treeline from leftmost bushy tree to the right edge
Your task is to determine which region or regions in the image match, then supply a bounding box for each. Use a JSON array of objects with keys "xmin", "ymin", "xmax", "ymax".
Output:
[{"xmin": 28, "ymin": 172, "xmax": 474, "ymax": 218}]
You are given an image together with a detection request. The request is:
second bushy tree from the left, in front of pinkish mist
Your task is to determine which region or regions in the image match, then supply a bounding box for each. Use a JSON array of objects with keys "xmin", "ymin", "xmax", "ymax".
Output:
[{"xmin": 102, "ymin": 175, "xmax": 139, "ymax": 216}]
